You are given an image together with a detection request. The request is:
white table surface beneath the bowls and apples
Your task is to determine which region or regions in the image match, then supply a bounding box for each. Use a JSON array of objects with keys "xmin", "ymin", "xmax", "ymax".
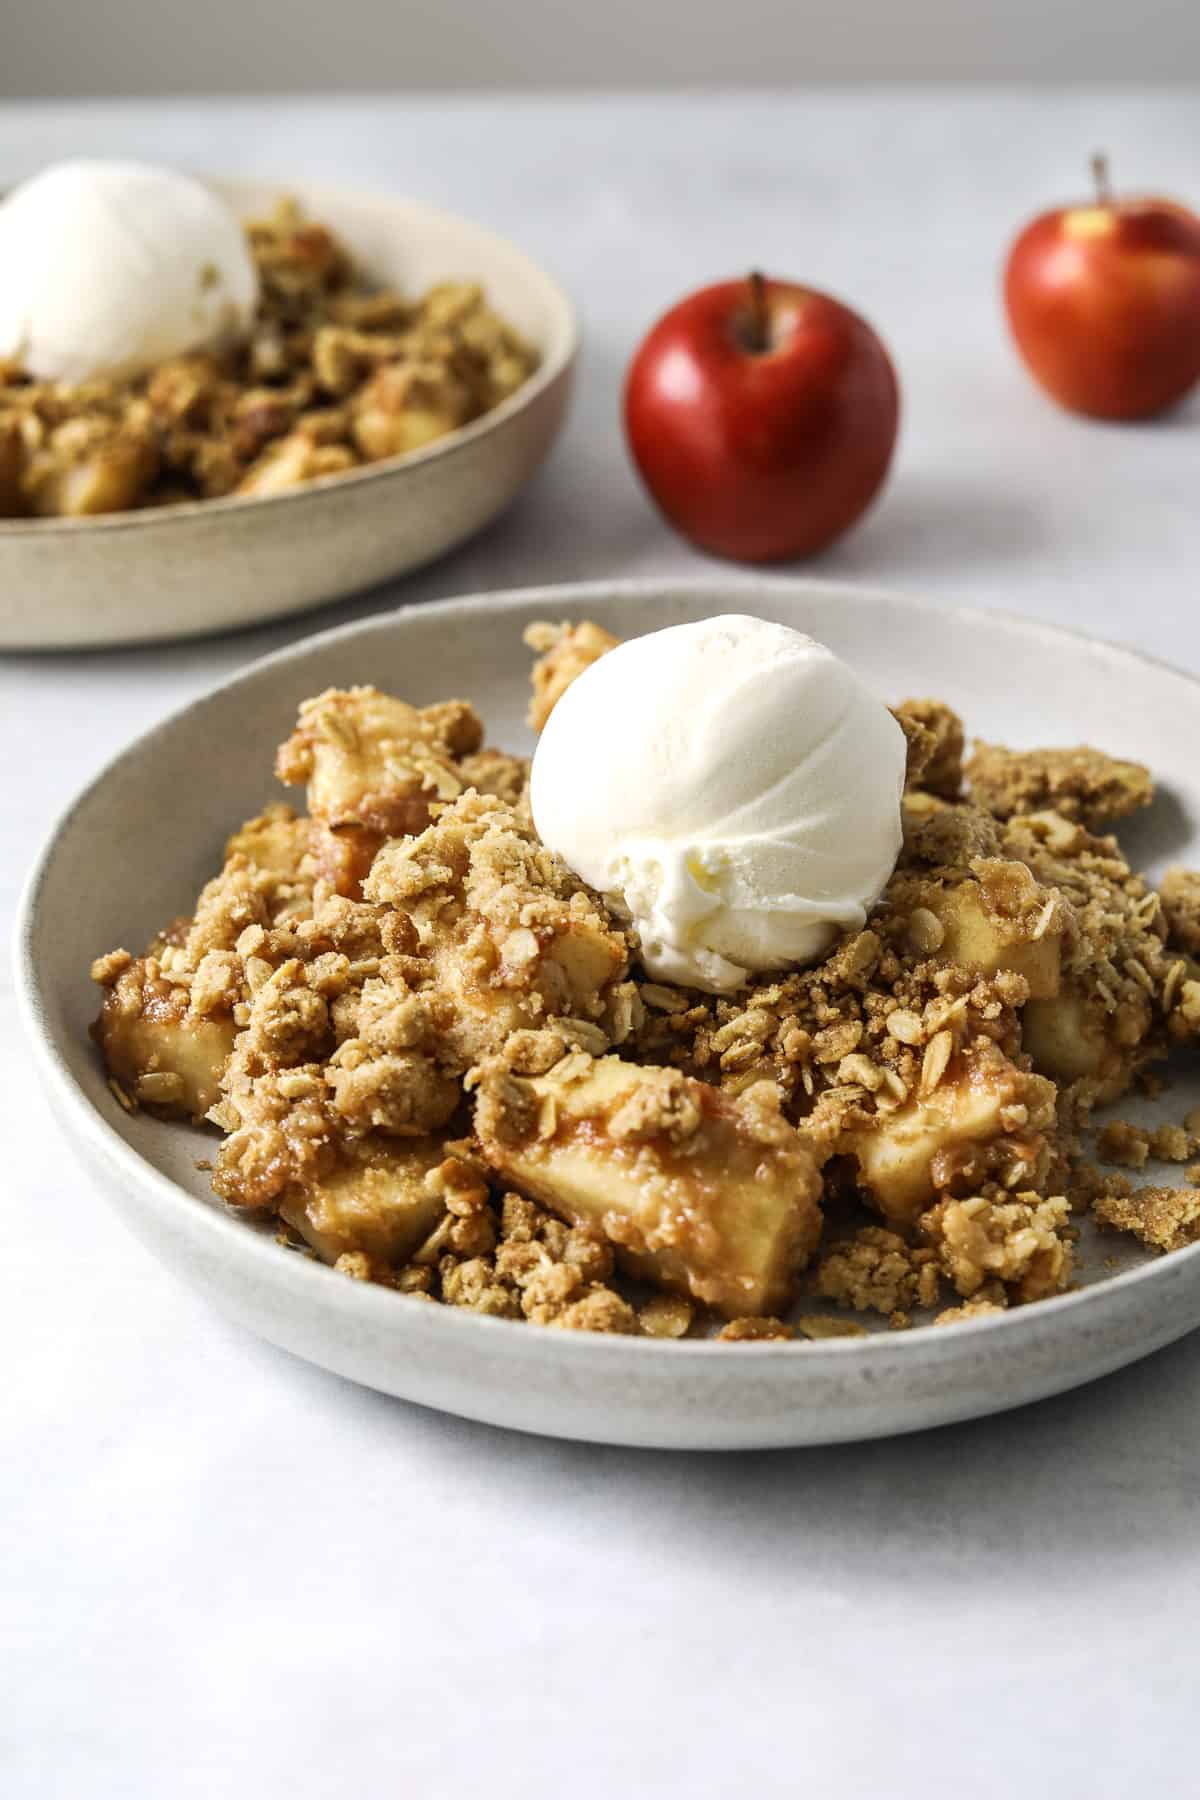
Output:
[{"xmin": 0, "ymin": 92, "xmax": 1200, "ymax": 1800}]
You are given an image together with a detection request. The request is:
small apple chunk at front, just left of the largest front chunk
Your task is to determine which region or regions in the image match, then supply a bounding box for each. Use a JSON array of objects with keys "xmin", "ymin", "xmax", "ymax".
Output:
[{"xmin": 279, "ymin": 1138, "xmax": 446, "ymax": 1265}]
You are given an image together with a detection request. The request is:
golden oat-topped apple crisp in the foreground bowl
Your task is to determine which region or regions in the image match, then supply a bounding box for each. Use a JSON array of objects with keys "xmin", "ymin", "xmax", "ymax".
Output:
[{"xmin": 92, "ymin": 619, "xmax": 1200, "ymax": 1343}]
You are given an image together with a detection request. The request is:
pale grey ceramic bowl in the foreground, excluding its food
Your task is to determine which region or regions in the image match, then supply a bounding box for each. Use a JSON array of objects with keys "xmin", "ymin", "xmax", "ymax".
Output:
[{"xmin": 18, "ymin": 580, "xmax": 1200, "ymax": 1449}]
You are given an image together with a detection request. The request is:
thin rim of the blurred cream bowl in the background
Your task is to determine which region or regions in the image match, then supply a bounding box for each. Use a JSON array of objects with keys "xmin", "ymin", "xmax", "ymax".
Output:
[{"xmin": 0, "ymin": 175, "xmax": 581, "ymax": 545}]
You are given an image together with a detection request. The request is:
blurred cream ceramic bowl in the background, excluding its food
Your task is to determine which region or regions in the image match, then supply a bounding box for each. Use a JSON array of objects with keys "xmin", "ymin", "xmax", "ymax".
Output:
[{"xmin": 0, "ymin": 182, "xmax": 578, "ymax": 650}]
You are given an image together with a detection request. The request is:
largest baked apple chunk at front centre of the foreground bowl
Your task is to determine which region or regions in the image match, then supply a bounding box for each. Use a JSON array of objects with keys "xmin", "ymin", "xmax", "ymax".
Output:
[{"xmin": 475, "ymin": 1051, "xmax": 820, "ymax": 1318}]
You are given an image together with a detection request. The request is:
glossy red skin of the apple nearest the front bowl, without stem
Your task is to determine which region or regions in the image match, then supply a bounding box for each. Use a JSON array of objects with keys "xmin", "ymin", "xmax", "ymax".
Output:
[{"xmin": 624, "ymin": 279, "xmax": 900, "ymax": 563}]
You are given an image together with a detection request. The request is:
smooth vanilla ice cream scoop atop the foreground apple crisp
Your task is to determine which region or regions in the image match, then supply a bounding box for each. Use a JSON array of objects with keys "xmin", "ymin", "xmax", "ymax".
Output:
[{"xmin": 531, "ymin": 614, "xmax": 905, "ymax": 994}]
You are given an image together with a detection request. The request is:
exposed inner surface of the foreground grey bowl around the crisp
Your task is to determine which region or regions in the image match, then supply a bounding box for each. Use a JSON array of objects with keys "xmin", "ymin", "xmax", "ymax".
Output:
[{"xmin": 27, "ymin": 581, "xmax": 1200, "ymax": 1317}]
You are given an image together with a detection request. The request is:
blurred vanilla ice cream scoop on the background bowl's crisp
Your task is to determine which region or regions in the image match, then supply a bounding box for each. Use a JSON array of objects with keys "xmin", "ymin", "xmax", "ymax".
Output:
[{"xmin": 0, "ymin": 162, "xmax": 259, "ymax": 382}]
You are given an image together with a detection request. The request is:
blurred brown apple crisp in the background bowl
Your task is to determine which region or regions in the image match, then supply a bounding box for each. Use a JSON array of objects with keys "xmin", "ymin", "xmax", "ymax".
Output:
[{"xmin": 0, "ymin": 203, "xmax": 538, "ymax": 518}]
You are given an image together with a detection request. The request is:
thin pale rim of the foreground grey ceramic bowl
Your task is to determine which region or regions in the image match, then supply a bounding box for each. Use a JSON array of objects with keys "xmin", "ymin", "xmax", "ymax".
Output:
[{"xmin": 13, "ymin": 574, "xmax": 1200, "ymax": 1366}]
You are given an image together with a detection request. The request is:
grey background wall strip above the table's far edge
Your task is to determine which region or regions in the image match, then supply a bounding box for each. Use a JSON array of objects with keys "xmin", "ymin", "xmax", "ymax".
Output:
[{"xmin": 0, "ymin": 0, "xmax": 1200, "ymax": 97}]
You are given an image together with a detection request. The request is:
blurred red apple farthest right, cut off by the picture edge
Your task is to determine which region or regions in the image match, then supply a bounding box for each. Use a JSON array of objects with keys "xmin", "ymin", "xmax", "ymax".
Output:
[{"xmin": 1004, "ymin": 157, "xmax": 1200, "ymax": 419}]
